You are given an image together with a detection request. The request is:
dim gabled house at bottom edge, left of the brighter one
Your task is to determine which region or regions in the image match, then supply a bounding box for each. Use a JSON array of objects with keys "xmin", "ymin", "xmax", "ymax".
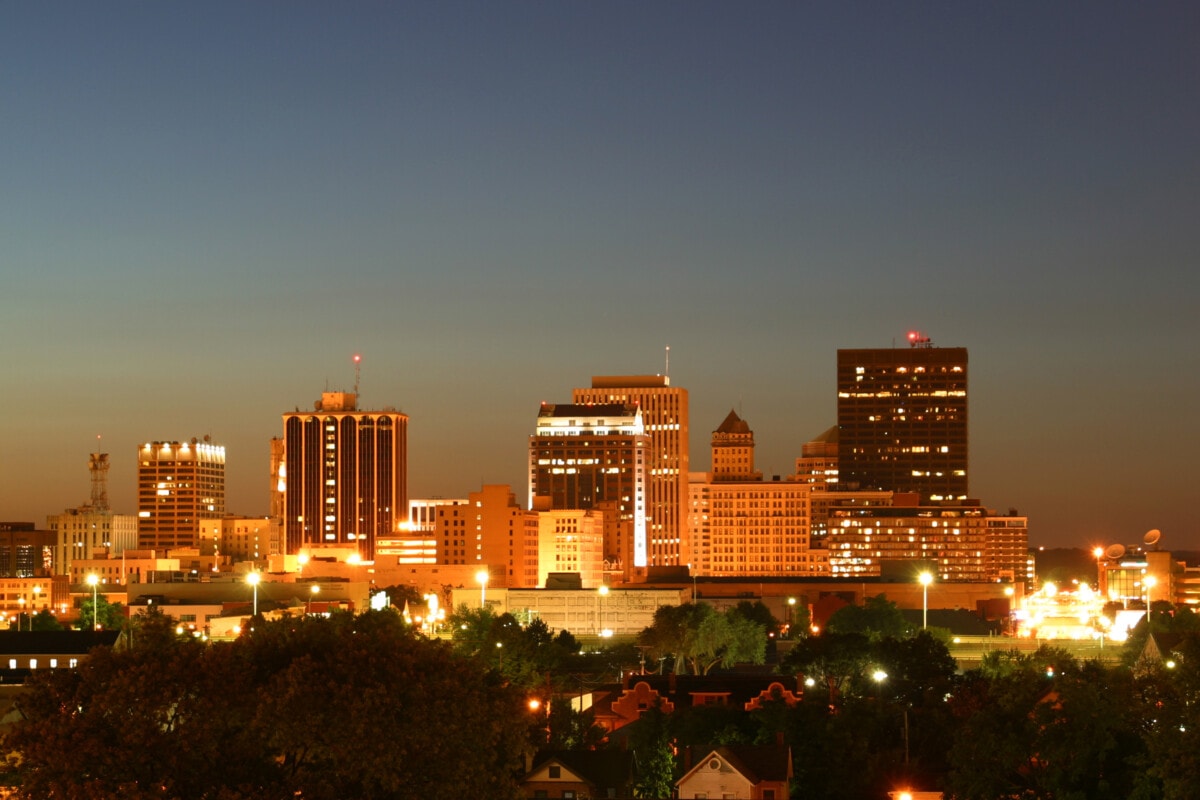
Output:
[{"xmin": 521, "ymin": 750, "xmax": 637, "ymax": 800}]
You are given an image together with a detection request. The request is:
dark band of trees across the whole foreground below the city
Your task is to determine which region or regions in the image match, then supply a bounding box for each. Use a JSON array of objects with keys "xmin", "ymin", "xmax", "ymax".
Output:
[{"xmin": 4, "ymin": 597, "xmax": 1200, "ymax": 800}]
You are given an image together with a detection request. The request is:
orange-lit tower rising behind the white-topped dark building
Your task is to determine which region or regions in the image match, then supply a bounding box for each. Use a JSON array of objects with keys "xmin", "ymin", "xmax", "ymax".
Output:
[{"xmin": 574, "ymin": 375, "xmax": 689, "ymax": 567}]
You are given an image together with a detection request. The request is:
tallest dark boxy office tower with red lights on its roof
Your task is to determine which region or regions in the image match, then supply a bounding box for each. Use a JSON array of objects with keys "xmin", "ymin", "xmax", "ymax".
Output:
[{"xmin": 838, "ymin": 335, "xmax": 967, "ymax": 501}]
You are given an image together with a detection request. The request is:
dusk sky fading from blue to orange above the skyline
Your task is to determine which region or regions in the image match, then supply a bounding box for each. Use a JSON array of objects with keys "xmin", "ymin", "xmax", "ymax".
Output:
[{"xmin": 0, "ymin": 0, "xmax": 1200, "ymax": 549}]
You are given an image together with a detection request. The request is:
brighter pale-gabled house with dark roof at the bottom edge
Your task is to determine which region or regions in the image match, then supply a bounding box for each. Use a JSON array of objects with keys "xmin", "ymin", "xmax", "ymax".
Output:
[{"xmin": 676, "ymin": 744, "xmax": 792, "ymax": 800}]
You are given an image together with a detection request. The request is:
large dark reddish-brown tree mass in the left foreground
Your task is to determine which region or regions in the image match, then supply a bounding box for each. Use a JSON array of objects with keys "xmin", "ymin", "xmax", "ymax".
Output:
[{"xmin": 7, "ymin": 610, "xmax": 533, "ymax": 800}]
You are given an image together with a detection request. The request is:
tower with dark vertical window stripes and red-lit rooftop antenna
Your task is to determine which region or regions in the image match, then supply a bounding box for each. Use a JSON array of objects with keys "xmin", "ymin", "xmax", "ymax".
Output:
[{"xmin": 275, "ymin": 392, "xmax": 408, "ymax": 561}]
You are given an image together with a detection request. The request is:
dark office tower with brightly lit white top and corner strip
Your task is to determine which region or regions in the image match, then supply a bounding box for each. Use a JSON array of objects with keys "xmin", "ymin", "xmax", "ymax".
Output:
[{"xmin": 529, "ymin": 403, "xmax": 649, "ymax": 579}]
